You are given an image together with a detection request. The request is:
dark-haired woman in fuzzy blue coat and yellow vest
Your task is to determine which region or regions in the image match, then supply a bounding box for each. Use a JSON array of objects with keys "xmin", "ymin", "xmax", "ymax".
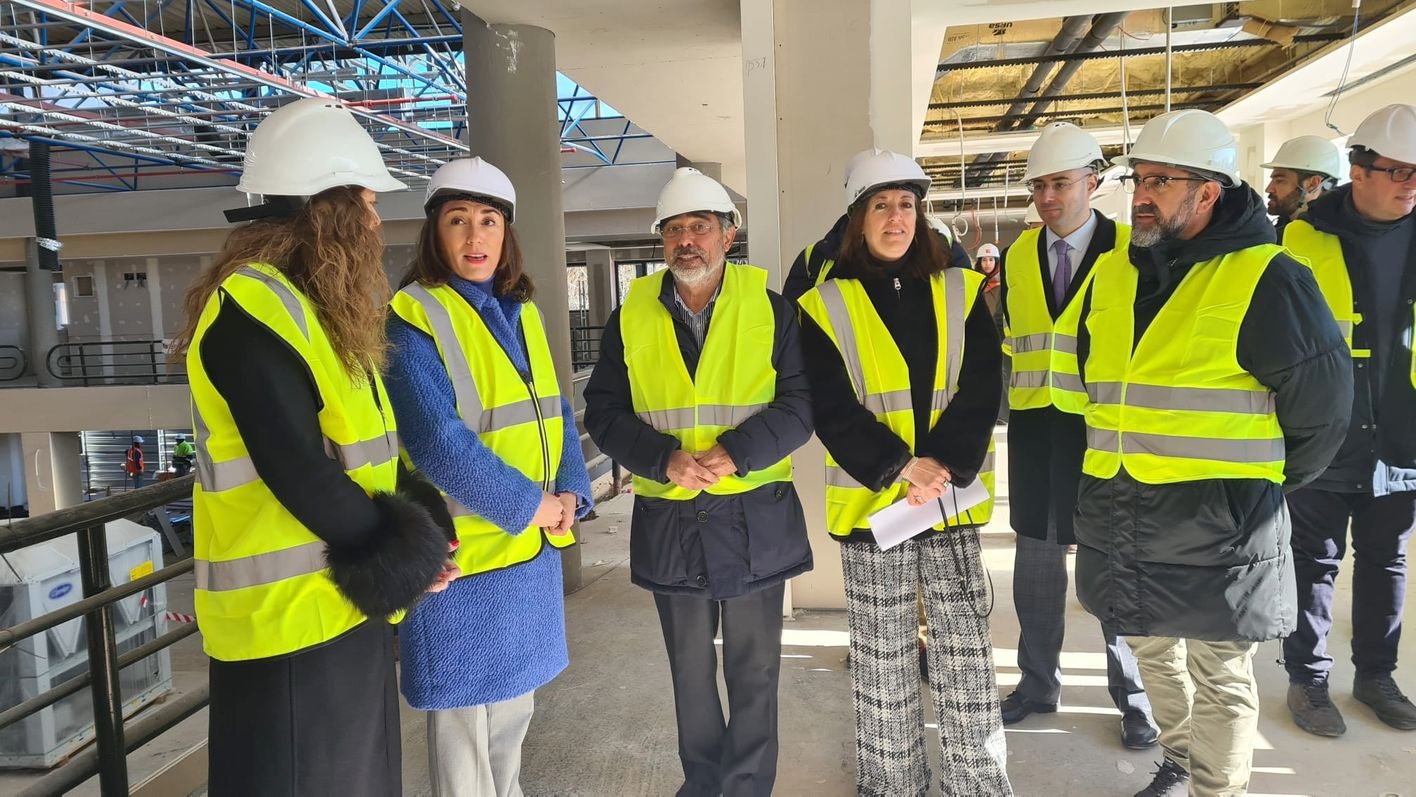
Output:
[{"xmin": 388, "ymin": 157, "xmax": 590, "ymax": 797}]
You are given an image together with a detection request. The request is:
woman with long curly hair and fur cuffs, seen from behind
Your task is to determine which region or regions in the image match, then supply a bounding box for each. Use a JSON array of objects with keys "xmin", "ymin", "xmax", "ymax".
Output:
[{"xmin": 173, "ymin": 99, "xmax": 457, "ymax": 797}]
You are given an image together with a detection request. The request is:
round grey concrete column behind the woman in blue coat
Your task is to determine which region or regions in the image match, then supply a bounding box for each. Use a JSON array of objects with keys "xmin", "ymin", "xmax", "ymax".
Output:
[{"xmin": 462, "ymin": 15, "xmax": 581, "ymax": 590}]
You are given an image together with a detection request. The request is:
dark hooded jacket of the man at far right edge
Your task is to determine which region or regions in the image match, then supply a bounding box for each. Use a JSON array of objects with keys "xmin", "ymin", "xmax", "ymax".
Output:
[{"xmin": 1303, "ymin": 185, "xmax": 1416, "ymax": 495}]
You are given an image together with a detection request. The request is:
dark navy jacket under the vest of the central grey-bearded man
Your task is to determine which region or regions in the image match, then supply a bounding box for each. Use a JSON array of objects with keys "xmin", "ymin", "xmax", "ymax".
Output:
[{"xmin": 585, "ymin": 267, "xmax": 811, "ymax": 600}]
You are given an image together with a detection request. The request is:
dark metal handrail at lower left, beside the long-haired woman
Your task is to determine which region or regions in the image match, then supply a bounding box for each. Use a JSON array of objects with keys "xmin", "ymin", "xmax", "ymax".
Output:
[{"xmin": 0, "ymin": 476, "xmax": 201, "ymax": 797}]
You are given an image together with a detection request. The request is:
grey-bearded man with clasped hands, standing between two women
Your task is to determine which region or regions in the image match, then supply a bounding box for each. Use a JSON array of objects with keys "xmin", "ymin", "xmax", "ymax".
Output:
[{"xmin": 585, "ymin": 168, "xmax": 811, "ymax": 797}]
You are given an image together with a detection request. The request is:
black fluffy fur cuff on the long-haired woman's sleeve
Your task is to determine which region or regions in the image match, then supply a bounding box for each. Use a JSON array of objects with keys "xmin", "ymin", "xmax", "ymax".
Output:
[{"xmin": 324, "ymin": 493, "xmax": 447, "ymax": 619}]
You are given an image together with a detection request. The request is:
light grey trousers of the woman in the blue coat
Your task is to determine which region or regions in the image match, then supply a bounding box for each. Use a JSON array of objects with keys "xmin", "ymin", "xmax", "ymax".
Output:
[{"xmin": 428, "ymin": 692, "xmax": 535, "ymax": 797}]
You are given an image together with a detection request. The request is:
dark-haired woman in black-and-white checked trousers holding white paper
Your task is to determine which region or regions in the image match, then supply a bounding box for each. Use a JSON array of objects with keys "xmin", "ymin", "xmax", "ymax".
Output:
[{"xmin": 799, "ymin": 150, "xmax": 1012, "ymax": 797}]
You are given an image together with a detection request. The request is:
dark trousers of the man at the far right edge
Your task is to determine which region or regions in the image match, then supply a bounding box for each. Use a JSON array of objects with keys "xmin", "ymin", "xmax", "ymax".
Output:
[{"xmin": 1283, "ymin": 488, "xmax": 1416, "ymax": 682}]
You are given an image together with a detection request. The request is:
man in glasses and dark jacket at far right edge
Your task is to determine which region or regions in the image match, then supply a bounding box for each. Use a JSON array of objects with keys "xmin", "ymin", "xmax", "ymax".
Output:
[{"xmin": 1283, "ymin": 105, "xmax": 1416, "ymax": 736}]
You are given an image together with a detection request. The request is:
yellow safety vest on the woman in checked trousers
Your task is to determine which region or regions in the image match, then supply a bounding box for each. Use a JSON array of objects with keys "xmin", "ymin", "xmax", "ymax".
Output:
[{"xmin": 799, "ymin": 268, "xmax": 994, "ymax": 537}]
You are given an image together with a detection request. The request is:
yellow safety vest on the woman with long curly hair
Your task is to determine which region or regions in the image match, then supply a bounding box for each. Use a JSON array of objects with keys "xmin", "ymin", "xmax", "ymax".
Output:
[{"xmin": 187, "ymin": 263, "xmax": 398, "ymax": 661}]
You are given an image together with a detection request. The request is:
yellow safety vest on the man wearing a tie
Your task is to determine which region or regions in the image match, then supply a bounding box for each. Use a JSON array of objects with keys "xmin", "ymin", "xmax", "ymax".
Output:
[{"xmin": 1003, "ymin": 224, "xmax": 1131, "ymax": 409}]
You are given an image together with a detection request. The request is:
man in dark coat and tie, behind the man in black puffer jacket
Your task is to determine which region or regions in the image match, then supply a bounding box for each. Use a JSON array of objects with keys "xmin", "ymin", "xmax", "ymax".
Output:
[{"xmin": 1003, "ymin": 122, "xmax": 1160, "ymax": 749}]
